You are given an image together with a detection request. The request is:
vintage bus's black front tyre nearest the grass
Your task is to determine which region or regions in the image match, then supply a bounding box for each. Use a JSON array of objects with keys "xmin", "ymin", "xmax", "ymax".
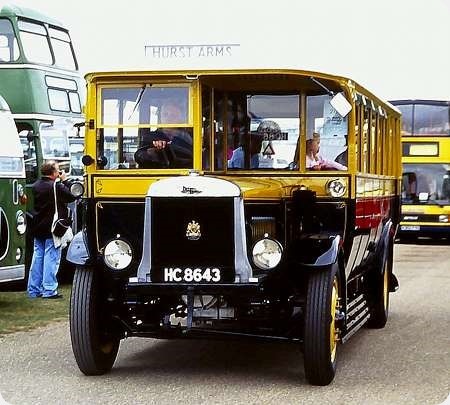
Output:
[{"xmin": 70, "ymin": 267, "xmax": 120, "ymax": 375}]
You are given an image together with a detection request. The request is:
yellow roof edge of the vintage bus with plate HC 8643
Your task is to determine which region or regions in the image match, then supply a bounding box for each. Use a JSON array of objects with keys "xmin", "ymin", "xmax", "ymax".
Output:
[{"xmin": 85, "ymin": 68, "xmax": 401, "ymax": 114}]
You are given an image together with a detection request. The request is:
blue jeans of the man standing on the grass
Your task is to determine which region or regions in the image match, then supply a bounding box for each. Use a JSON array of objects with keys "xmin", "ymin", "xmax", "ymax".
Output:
[{"xmin": 27, "ymin": 238, "xmax": 61, "ymax": 298}]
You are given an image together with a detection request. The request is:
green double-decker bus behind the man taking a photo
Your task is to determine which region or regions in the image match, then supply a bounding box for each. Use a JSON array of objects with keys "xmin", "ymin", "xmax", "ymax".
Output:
[{"xmin": 0, "ymin": 6, "xmax": 85, "ymax": 268}]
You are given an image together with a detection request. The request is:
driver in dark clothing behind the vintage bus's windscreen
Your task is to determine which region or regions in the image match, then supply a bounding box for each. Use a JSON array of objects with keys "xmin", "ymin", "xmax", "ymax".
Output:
[{"xmin": 135, "ymin": 100, "xmax": 192, "ymax": 168}]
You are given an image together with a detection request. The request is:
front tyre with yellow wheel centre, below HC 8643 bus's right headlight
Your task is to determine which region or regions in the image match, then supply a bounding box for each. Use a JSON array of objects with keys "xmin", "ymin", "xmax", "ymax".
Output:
[{"xmin": 304, "ymin": 264, "xmax": 339, "ymax": 385}]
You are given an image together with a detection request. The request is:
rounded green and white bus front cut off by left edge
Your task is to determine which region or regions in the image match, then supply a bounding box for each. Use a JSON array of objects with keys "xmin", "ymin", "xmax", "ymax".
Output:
[{"xmin": 0, "ymin": 96, "xmax": 26, "ymax": 283}]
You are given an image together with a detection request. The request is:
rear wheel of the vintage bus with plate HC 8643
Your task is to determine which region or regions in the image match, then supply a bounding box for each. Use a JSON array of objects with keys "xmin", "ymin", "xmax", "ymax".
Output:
[{"xmin": 367, "ymin": 241, "xmax": 394, "ymax": 329}]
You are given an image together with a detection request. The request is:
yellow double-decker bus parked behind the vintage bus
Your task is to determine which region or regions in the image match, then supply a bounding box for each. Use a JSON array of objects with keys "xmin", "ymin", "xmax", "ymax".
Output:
[{"xmin": 392, "ymin": 100, "xmax": 450, "ymax": 239}]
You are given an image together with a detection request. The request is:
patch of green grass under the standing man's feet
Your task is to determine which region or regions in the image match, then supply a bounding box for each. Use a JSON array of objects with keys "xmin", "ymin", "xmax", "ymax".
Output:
[{"xmin": 0, "ymin": 285, "xmax": 72, "ymax": 336}]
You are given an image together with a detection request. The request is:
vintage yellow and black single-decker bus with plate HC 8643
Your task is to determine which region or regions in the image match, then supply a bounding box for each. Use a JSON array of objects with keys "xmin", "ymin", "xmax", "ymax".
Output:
[{"xmin": 67, "ymin": 70, "xmax": 401, "ymax": 385}]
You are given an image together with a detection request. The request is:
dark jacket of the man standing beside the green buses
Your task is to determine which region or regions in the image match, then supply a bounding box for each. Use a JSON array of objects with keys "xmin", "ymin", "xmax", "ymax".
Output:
[{"xmin": 31, "ymin": 176, "xmax": 75, "ymax": 239}]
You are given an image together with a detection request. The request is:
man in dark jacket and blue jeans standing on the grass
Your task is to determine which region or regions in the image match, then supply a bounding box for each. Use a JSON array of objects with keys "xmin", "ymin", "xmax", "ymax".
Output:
[{"xmin": 27, "ymin": 160, "xmax": 75, "ymax": 299}]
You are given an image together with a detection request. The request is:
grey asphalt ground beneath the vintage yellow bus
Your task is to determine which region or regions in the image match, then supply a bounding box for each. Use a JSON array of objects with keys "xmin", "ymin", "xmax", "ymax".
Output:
[{"xmin": 0, "ymin": 245, "xmax": 450, "ymax": 405}]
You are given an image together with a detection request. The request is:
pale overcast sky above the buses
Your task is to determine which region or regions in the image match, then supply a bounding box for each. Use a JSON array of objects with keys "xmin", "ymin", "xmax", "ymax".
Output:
[{"xmin": 4, "ymin": 0, "xmax": 450, "ymax": 99}]
